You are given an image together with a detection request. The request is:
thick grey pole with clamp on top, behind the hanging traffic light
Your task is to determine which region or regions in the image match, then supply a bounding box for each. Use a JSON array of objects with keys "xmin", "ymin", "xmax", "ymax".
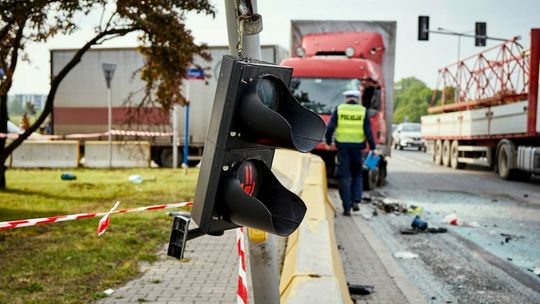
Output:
[{"xmin": 225, "ymin": 0, "xmax": 279, "ymax": 303}]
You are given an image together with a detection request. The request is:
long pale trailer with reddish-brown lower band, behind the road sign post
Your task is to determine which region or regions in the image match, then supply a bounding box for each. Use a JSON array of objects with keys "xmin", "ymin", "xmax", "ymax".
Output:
[{"xmin": 50, "ymin": 45, "xmax": 287, "ymax": 167}]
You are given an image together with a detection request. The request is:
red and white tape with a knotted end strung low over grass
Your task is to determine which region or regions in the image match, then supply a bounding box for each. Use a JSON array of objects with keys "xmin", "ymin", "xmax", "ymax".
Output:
[{"xmin": 0, "ymin": 202, "xmax": 193, "ymax": 236}]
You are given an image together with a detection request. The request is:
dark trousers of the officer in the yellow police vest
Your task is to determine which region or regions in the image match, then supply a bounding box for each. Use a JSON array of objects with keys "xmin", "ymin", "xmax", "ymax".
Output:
[{"xmin": 336, "ymin": 148, "xmax": 362, "ymax": 211}]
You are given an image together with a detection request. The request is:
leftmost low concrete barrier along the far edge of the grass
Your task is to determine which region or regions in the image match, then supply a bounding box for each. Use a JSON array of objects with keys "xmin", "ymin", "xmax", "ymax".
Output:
[{"xmin": 10, "ymin": 140, "xmax": 79, "ymax": 168}]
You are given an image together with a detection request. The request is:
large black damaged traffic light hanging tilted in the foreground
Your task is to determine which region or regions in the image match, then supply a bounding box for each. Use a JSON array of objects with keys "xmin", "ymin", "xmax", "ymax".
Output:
[{"xmin": 192, "ymin": 56, "xmax": 326, "ymax": 236}]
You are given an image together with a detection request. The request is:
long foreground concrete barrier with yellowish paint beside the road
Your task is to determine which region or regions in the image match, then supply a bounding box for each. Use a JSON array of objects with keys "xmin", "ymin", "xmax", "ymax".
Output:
[{"xmin": 272, "ymin": 150, "xmax": 352, "ymax": 304}]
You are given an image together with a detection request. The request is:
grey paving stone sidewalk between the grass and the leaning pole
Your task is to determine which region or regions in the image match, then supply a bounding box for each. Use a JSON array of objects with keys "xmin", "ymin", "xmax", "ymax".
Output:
[{"xmin": 97, "ymin": 230, "xmax": 253, "ymax": 304}]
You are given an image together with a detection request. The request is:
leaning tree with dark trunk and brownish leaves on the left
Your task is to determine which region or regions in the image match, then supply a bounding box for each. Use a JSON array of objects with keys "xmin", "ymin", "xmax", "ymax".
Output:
[{"xmin": 0, "ymin": 0, "xmax": 215, "ymax": 189}]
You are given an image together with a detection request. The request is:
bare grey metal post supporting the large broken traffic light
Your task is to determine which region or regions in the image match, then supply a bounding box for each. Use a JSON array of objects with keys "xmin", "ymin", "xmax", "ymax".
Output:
[{"xmin": 225, "ymin": 0, "xmax": 279, "ymax": 303}]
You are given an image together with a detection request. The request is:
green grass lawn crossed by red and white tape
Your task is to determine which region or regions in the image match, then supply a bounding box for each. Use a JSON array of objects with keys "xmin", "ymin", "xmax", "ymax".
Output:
[{"xmin": 0, "ymin": 169, "xmax": 198, "ymax": 304}]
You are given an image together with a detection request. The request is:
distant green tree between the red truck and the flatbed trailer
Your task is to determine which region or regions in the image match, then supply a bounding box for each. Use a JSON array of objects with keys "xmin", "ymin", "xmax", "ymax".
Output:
[{"xmin": 394, "ymin": 77, "xmax": 433, "ymax": 123}]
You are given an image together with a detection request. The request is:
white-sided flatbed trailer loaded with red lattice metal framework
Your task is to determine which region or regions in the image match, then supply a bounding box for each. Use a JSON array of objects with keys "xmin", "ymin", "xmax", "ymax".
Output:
[{"xmin": 421, "ymin": 29, "xmax": 540, "ymax": 179}]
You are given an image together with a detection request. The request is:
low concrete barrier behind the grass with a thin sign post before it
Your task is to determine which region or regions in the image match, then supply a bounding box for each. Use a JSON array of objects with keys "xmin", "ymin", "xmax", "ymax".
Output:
[{"xmin": 84, "ymin": 141, "xmax": 150, "ymax": 168}]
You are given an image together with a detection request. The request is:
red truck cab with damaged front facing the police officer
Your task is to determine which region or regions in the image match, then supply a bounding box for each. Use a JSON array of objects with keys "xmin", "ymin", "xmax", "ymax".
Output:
[{"xmin": 281, "ymin": 32, "xmax": 387, "ymax": 189}]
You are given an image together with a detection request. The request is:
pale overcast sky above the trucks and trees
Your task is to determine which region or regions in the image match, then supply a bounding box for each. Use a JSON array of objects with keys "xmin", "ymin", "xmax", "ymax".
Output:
[{"xmin": 10, "ymin": 0, "xmax": 540, "ymax": 94}]
